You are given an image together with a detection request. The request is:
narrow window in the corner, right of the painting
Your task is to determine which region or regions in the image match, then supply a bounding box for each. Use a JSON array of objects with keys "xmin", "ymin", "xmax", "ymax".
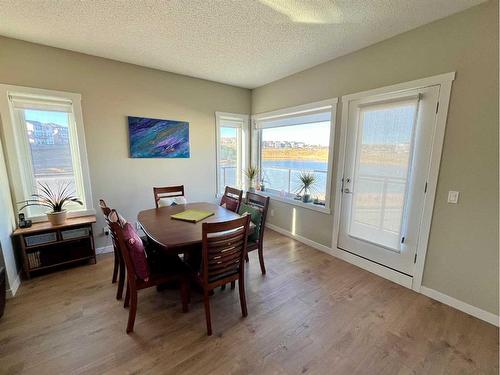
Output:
[{"xmin": 216, "ymin": 112, "xmax": 249, "ymax": 194}]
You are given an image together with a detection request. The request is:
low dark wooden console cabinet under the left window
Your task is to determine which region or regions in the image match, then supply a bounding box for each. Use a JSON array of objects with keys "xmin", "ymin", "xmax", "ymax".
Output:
[{"xmin": 13, "ymin": 216, "xmax": 97, "ymax": 279}]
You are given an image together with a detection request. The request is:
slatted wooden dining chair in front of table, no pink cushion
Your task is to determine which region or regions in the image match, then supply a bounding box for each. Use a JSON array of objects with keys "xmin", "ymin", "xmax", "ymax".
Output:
[{"xmin": 194, "ymin": 216, "xmax": 250, "ymax": 336}]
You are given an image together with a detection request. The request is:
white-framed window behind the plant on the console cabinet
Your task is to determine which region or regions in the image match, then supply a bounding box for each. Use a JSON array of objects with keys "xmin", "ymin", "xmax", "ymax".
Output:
[{"xmin": 0, "ymin": 85, "xmax": 93, "ymax": 220}]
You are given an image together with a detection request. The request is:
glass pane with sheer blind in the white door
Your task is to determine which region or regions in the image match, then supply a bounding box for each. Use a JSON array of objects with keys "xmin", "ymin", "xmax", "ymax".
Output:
[{"xmin": 349, "ymin": 96, "xmax": 419, "ymax": 251}]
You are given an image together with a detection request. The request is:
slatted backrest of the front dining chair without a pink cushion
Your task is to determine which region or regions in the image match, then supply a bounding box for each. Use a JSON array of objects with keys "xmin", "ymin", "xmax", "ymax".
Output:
[{"xmin": 201, "ymin": 216, "xmax": 250, "ymax": 289}]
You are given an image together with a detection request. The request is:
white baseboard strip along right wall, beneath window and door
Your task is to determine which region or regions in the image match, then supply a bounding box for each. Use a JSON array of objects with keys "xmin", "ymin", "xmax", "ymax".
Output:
[{"xmin": 266, "ymin": 223, "xmax": 500, "ymax": 327}]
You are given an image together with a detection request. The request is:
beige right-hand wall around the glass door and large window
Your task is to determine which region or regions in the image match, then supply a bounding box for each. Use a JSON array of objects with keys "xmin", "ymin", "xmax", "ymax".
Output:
[{"xmin": 252, "ymin": 0, "xmax": 499, "ymax": 315}]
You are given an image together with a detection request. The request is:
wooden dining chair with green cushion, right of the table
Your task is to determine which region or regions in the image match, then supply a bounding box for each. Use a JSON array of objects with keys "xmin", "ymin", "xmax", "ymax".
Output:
[{"xmin": 238, "ymin": 192, "xmax": 269, "ymax": 275}]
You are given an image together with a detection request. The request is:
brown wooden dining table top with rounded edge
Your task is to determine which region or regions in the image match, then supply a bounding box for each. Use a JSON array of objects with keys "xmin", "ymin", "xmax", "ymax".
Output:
[{"xmin": 137, "ymin": 202, "xmax": 240, "ymax": 254}]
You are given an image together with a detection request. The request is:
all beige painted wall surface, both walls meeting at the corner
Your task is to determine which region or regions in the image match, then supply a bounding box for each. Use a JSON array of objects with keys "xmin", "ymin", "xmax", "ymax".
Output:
[{"xmin": 0, "ymin": 0, "xmax": 499, "ymax": 320}]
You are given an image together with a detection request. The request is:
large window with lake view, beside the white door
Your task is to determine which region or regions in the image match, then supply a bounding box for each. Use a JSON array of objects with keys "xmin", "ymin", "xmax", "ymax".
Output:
[{"xmin": 255, "ymin": 100, "xmax": 337, "ymax": 210}]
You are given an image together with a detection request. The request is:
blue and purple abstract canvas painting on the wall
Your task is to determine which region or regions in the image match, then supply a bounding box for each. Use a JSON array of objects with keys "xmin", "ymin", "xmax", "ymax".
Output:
[{"xmin": 128, "ymin": 116, "xmax": 189, "ymax": 158}]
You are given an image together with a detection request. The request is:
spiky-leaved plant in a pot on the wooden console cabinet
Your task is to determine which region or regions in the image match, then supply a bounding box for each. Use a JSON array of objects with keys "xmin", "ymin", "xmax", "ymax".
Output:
[{"xmin": 19, "ymin": 182, "xmax": 83, "ymax": 225}]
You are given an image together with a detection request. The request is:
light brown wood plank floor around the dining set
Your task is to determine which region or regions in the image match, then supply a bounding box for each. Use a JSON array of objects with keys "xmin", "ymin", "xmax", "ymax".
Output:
[{"xmin": 0, "ymin": 231, "xmax": 499, "ymax": 375}]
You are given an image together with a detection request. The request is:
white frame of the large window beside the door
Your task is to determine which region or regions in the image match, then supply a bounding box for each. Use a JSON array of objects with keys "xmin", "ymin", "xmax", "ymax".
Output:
[{"xmin": 252, "ymin": 98, "xmax": 338, "ymax": 214}]
